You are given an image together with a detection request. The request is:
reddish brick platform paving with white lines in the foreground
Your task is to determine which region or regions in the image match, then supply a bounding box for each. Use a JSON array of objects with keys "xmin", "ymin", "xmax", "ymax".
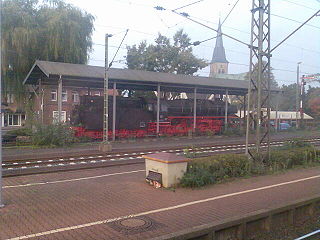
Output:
[{"xmin": 0, "ymin": 164, "xmax": 320, "ymax": 240}]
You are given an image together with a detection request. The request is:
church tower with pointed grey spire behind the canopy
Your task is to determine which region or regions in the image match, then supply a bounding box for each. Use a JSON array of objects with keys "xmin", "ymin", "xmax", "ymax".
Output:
[{"xmin": 209, "ymin": 20, "xmax": 229, "ymax": 77}]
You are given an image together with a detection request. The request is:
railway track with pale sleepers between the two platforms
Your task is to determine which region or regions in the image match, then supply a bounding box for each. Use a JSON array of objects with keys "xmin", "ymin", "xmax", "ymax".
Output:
[{"xmin": 2, "ymin": 138, "xmax": 320, "ymax": 177}]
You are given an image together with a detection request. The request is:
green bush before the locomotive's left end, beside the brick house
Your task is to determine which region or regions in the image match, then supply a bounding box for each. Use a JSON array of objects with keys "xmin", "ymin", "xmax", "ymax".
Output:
[{"xmin": 32, "ymin": 124, "xmax": 75, "ymax": 147}]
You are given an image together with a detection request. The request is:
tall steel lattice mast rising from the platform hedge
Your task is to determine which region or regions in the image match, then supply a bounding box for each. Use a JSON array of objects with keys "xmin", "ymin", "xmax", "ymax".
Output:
[{"xmin": 246, "ymin": 0, "xmax": 271, "ymax": 159}]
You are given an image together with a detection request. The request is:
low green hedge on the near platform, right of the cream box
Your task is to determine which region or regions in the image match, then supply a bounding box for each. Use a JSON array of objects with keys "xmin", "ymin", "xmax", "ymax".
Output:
[{"xmin": 180, "ymin": 146, "xmax": 320, "ymax": 188}]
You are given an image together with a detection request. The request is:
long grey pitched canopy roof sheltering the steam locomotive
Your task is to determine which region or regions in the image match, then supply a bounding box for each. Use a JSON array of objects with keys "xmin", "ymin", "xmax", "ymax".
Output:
[{"xmin": 23, "ymin": 60, "xmax": 276, "ymax": 95}]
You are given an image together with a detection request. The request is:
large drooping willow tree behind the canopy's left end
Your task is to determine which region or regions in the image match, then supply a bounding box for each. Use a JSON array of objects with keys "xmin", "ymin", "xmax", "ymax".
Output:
[{"xmin": 1, "ymin": 0, "xmax": 94, "ymax": 102}]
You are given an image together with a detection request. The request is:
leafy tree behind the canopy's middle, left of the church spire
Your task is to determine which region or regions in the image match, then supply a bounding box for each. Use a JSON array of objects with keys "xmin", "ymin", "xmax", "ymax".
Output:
[{"xmin": 126, "ymin": 30, "xmax": 208, "ymax": 98}]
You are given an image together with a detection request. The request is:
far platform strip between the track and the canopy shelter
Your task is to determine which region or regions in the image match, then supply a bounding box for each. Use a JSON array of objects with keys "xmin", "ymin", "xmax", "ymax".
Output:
[{"xmin": 3, "ymin": 129, "xmax": 320, "ymax": 160}]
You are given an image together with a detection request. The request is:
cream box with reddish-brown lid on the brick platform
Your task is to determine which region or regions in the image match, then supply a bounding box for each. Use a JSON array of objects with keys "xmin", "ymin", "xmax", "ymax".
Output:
[{"xmin": 143, "ymin": 153, "xmax": 189, "ymax": 188}]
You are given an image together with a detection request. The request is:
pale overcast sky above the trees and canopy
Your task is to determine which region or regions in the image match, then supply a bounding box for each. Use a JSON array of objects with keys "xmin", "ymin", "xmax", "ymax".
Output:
[{"xmin": 66, "ymin": 0, "xmax": 320, "ymax": 86}]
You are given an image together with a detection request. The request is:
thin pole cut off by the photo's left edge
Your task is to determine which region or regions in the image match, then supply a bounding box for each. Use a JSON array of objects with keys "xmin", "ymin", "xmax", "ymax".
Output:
[{"xmin": 0, "ymin": 1, "xmax": 4, "ymax": 208}]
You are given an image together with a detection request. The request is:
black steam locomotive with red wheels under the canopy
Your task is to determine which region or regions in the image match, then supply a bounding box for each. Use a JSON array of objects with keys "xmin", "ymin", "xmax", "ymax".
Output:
[{"xmin": 70, "ymin": 95, "xmax": 237, "ymax": 139}]
